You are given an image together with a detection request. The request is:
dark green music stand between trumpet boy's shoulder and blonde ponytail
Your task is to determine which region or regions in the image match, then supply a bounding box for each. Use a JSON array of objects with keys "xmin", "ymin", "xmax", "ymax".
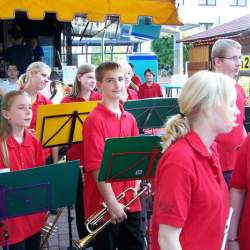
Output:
[{"xmin": 124, "ymin": 98, "xmax": 179, "ymax": 129}]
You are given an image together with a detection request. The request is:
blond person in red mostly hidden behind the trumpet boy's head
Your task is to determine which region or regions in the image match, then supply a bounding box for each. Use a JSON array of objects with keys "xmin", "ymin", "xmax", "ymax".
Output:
[{"xmin": 121, "ymin": 63, "xmax": 138, "ymax": 102}]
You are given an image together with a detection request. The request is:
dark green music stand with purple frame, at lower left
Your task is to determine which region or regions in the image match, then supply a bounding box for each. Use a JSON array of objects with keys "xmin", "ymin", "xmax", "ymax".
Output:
[{"xmin": 0, "ymin": 161, "xmax": 79, "ymax": 249}]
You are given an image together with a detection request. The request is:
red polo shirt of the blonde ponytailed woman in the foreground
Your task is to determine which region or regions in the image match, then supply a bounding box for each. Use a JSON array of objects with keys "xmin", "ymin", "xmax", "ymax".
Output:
[{"xmin": 153, "ymin": 131, "xmax": 228, "ymax": 250}]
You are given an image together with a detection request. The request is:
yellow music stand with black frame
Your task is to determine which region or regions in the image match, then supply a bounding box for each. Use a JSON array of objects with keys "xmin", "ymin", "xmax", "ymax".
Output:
[{"xmin": 36, "ymin": 101, "xmax": 98, "ymax": 148}]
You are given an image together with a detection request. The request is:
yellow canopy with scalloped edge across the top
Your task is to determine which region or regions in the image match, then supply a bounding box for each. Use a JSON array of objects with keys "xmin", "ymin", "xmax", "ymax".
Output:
[{"xmin": 0, "ymin": 0, "xmax": 181, "ymax": 25}]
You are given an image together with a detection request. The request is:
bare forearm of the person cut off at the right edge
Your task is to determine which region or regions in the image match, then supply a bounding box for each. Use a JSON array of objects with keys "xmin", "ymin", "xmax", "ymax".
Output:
[{"xmin": 228, "ymin": 188, "xmax": 246, "ymax": 249}]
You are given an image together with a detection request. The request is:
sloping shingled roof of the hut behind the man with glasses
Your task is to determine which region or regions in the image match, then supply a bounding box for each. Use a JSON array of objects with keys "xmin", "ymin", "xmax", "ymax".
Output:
[{"xmin": 180, "ymin": 14, "xmax": 250, "ymax": 43}]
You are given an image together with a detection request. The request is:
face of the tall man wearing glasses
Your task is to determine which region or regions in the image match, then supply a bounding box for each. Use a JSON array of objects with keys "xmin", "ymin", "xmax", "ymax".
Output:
[{"xmin": 214, "ymin": 47, "xmax": 241, "ymax": 78}]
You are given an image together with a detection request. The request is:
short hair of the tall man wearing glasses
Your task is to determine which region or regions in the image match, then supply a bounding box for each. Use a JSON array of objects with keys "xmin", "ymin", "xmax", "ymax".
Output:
[{"xmin": 211, "ymin": 39, "xmax": 242, "ymax": 65}]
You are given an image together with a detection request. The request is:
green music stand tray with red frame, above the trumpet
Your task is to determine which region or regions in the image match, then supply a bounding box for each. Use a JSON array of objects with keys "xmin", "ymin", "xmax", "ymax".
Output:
[{"xmin": 98, "ymin": 136, "xmax": 162, "ymax": 182}]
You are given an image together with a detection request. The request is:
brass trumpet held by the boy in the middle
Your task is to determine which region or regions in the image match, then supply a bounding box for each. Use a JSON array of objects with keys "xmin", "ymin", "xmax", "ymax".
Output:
[{"xmin": 73, "ymin": 185, "xmax": 149, "ymax": 250}]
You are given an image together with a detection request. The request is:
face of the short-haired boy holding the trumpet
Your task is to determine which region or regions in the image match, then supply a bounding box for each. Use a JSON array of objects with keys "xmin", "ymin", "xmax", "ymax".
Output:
[{"xmin": 97, "ymin": 70, "xmax": 125, "ymax": 100}]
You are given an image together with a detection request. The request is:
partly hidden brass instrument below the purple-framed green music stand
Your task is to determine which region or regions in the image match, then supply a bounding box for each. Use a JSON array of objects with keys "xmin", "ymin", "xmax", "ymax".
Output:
[{"xmin": 40, "ymin": 208, "xmax": 63, "ymax": 249}]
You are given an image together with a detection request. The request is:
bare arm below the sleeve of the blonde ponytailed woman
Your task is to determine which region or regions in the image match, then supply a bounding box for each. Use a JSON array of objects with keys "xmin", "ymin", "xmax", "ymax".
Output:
[{"xmin": 158, "ymin": 224, "xmax": 182, "ymax": 250}]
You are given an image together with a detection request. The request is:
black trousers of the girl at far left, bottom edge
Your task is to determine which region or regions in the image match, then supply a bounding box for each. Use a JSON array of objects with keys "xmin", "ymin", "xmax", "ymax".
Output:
[{"xmin": 3, "ymin": 232, "xmax": 41, "ymax": 250}]
